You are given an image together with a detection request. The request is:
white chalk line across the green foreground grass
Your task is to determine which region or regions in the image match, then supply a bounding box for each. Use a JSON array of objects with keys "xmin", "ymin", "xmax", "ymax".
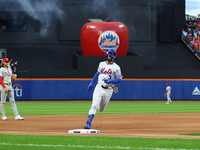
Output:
[{"xmin": 0, "ymin": 143, "xmax": 199, "ymax": 150}]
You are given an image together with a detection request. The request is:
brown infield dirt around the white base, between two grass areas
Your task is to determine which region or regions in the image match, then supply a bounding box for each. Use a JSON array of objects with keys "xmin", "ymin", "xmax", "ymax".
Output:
[{"xmin": 0, "ymin": 113, "xmax": 200, "ymax": 139}]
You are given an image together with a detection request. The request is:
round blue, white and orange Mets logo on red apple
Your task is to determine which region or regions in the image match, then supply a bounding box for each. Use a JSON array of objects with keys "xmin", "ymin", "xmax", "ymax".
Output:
[{"xmin": 98, "ymin": 31, "xmax": 120, "ymax": 52}]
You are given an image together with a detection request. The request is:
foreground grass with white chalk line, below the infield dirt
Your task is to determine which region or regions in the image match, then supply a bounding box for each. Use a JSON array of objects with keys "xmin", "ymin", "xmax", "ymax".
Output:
[{"xmin": 0, "ymin": 134, "xmax": 200, "ymax": 150}]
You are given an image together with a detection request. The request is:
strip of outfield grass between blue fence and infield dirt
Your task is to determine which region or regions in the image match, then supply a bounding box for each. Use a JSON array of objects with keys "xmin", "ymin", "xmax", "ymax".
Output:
[{"xmin": 6, "ymin": 101, "xmax": 200, "ymax": 116}]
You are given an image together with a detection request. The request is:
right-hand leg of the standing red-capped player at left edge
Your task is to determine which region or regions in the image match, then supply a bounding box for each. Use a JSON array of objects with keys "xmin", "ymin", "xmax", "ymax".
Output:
[{"xmin": 8, "ymin": 88, "xmax": 24, "ymax": 120}]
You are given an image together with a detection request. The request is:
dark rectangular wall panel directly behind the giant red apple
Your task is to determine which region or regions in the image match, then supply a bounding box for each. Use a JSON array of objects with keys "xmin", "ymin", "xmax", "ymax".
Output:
[{"xmin": 58, "ymin": 5, "xmax": 152, "ymax": 41}]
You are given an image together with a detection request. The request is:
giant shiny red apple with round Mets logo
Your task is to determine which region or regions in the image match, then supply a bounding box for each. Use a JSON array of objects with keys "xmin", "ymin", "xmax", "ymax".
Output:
[{"xmin": 81, "ymin": 22, "xmax": 129, "ymax": 56}]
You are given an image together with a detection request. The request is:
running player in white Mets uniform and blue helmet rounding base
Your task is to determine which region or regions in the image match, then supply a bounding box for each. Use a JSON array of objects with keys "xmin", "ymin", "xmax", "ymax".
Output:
[{"xmin": 84, "ymin": 49, "xmax": 122, "ymax": 129}]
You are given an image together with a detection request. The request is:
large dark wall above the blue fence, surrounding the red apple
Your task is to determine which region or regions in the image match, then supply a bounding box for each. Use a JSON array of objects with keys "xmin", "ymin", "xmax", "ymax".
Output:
[{"xmin": 0, "ymin": 0, "xmax": 188, "ymax": 78}]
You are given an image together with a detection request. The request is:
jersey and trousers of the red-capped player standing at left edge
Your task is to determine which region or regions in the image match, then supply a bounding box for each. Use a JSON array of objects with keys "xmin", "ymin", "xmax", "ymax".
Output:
[{"xmin": 0, "ymin": 66, "xmax": 19, "ymax": 116}]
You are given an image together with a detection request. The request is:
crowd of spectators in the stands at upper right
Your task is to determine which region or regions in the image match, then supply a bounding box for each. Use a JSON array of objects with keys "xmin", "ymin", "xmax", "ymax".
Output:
[{"xmin": 182, "ymin": 21, "xmax": 200, "ymax": 57}]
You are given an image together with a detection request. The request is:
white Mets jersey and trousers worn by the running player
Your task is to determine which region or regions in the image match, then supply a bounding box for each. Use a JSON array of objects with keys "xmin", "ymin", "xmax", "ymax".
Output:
[{"xmin": 89, "ymin": 61, "xmax": 122, "ymax": 115}]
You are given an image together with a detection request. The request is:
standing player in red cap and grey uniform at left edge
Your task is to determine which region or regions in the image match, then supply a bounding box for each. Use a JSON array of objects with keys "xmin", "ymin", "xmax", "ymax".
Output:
[{"xmin": 0, "ymin": 58, "xmax": 24, "ymax": 120}]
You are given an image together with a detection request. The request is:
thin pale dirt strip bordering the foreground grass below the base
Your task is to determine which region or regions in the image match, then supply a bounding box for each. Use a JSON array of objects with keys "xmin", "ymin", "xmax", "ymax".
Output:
[{"xmin": 0, "ymin": 131, "xmax": 200, "ymax": 139}]
